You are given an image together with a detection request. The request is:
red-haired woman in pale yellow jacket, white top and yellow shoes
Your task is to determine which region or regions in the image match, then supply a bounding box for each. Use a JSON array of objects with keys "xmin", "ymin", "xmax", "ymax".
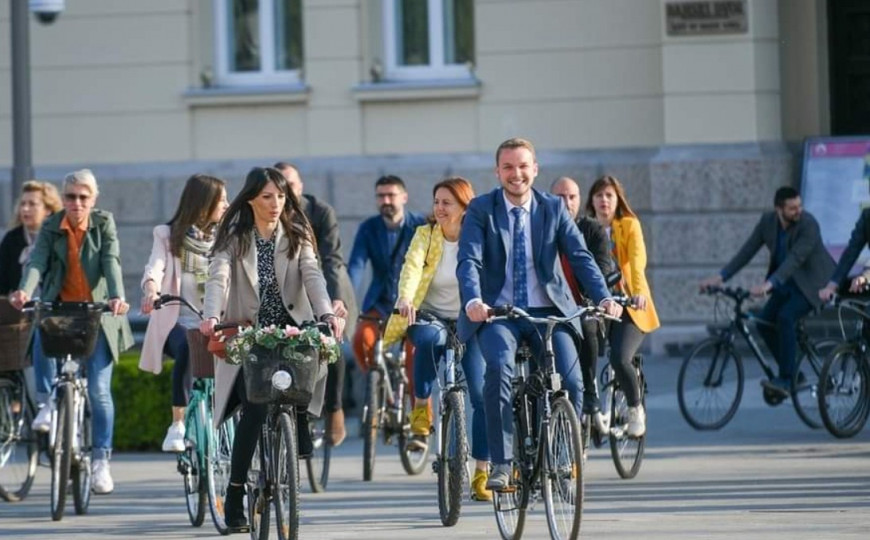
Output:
[{"xmin": 384, "ymin": 177, "xmax": 492, "ymax": 501}]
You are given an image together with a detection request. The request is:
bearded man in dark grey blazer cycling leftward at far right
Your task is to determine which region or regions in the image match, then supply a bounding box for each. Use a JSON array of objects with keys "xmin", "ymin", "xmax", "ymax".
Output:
[{"xmin": 701, "ymin": 186, "xmax": 834, "ymax": 397}]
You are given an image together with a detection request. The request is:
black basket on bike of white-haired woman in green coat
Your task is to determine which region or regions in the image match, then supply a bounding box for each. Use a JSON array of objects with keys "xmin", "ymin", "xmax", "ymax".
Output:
[{"xmin": 37, "ymin": 302, "xmax": 103, "ymax": 358}]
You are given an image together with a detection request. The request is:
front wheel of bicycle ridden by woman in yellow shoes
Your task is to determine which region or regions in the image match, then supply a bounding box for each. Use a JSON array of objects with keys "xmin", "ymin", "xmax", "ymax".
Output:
[{"xmin": 436, "ymin": 392, "xmax": 468, "ymax": 527}]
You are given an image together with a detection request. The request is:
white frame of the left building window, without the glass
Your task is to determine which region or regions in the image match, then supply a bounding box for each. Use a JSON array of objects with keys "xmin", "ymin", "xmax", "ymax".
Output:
[{"xmin": 213, "ymin": 0, "xmax": 305, "ymax": 86}]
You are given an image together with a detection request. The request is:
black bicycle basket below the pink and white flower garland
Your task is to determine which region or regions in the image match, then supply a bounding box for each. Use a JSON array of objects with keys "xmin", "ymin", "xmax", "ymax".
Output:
[{"xmin": 242, "ymin": 345, "xmax": 326, "ymax": 406}]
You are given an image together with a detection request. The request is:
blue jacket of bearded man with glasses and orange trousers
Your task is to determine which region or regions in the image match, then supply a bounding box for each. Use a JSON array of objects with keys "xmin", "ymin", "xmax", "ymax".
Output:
[{"xmin": 347, "ymin": 212, "xmax": 426, "ymax": 316}]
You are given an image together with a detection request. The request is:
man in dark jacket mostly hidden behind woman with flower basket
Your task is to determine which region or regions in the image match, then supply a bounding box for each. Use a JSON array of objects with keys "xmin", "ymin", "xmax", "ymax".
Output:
[{"xmin": 275, "ymin": 161, "xmax": 359, "ymax": 446}]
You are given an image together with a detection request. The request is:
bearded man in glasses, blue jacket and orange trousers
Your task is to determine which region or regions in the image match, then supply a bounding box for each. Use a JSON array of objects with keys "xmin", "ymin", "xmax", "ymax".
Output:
[{"xmin": 347, "ymin": 175, "xmax": 426, "ymax": 388}]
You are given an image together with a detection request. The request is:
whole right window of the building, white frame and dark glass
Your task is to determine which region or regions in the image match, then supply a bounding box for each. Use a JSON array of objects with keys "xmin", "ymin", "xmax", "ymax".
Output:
[{"xmin": 383, "ymin": 0, "xmax": 474, "ymax": 80}]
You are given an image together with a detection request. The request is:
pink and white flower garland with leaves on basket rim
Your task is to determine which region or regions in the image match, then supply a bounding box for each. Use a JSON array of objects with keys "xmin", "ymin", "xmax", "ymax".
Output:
[{"xmin": 226, "ymin": 324, "xmax": 341, "ymax": 364}]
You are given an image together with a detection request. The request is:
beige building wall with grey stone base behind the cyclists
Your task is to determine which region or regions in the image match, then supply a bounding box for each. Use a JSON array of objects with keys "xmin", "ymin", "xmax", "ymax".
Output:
[{"xmin": 0, "ymin": 0, "xmax": 860, "ymax": 347}]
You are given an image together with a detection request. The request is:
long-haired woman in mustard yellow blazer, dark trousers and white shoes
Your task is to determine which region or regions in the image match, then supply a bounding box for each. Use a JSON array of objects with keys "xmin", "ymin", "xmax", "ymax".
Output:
[{"xmin": 586, "ymin": 176, "xmax": 659, "ymax": 437}]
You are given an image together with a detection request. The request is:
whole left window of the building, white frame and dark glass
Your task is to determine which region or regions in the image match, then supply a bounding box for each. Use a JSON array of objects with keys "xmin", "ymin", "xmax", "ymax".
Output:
[{"xmin": 215, "ymin": 0, "xmax": 302, "ymax": 86}]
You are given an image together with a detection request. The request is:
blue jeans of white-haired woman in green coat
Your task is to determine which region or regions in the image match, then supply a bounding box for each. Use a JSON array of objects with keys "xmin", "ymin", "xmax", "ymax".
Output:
[{"xmin": 33, "ymin": 332, "xmax": 115, "ymax": 459}]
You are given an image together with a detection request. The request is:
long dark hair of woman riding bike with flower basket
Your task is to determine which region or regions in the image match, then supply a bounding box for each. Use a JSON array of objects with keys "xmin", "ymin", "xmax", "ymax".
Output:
[{"xmin": 214, "ymin": 167, "xmax": 314, "ymax": 259}]
